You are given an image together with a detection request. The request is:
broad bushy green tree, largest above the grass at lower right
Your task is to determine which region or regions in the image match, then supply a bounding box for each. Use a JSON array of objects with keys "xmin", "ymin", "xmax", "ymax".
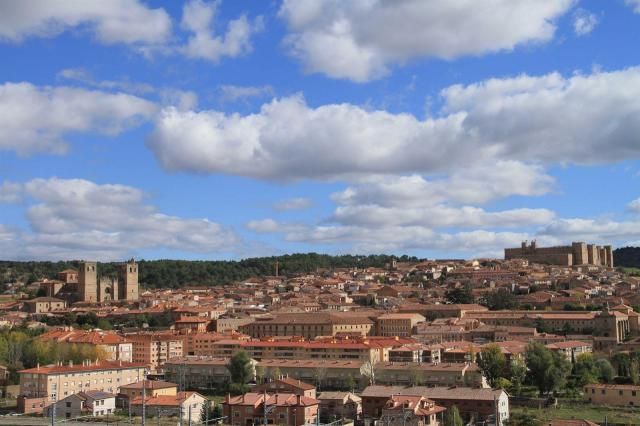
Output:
[{"xmin": 525, "ymin": 342, "xmax": 571, "ymax": 396}]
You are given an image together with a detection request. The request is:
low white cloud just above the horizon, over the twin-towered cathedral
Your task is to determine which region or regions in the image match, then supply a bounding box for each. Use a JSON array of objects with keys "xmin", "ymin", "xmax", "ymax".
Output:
[{"xmin": 0, "ymin": 178, "xmax": 239, "ymax": 259}]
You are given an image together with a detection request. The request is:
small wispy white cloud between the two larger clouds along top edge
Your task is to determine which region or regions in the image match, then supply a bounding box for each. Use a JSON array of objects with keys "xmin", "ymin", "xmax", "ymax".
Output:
[{"xmin": 180, "ymin": 0, "xmax": 263, "ymax": 62}]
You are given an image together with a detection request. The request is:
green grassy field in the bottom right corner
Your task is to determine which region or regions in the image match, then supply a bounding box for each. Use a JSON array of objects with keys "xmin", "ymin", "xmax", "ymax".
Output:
[{"xmin": 511, "ymin": 402, "xmax": 640, "ymax": 425}]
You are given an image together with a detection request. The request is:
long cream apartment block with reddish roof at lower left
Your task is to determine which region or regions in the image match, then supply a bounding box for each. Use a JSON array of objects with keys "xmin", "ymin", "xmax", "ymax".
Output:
[{"xmin": 18, "ymin": 361, "xmax": 145, "ymax": 413}]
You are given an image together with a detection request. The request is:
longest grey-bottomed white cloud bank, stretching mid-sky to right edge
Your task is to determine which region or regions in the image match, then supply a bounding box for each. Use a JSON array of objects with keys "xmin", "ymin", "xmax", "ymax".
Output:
[{"xmin": 148, "ymin": 68, "xmax": 640, "ymax": 180}]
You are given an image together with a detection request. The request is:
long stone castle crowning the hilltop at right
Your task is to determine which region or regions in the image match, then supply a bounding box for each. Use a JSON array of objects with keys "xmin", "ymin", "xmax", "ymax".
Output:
[{"xmin": 504, "ymin": 241, "xmax": 613, "ymax": 268}]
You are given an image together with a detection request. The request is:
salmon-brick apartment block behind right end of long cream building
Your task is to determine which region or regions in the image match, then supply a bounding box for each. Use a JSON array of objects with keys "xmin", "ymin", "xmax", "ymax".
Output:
[{"xmin": 127, "ymin": 333, "xmax": 183, "ymax": 371}]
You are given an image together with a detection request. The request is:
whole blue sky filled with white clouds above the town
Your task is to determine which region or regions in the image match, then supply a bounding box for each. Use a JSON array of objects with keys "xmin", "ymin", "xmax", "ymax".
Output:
[{"xmin": 0, "ymin": 0, "xmax": 640, "ymax": 261}]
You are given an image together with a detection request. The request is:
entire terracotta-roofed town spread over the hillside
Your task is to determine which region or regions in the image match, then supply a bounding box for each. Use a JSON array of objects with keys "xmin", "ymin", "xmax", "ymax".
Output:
[{"xmin": 0, "ymin": 242, "xmax": 640, "ymax": 426}]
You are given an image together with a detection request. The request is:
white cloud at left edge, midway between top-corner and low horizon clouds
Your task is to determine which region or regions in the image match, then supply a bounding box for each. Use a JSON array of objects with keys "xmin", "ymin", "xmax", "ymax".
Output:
[{"xmin": 0, "ymin": 83, "xmax": 156, "ymax": 155}]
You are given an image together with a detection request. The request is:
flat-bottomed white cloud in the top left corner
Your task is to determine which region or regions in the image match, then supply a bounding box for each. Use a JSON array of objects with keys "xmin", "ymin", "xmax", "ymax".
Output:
[{"xmin": 0, "ymin": 0, "xmax": 171, "ymax": 44}]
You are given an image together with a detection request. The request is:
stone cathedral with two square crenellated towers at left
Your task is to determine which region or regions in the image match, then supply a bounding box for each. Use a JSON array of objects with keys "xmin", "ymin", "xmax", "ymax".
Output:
[{"xmin": 41, "ymin": 259, "xmax": 139, "ymax": 303}]
